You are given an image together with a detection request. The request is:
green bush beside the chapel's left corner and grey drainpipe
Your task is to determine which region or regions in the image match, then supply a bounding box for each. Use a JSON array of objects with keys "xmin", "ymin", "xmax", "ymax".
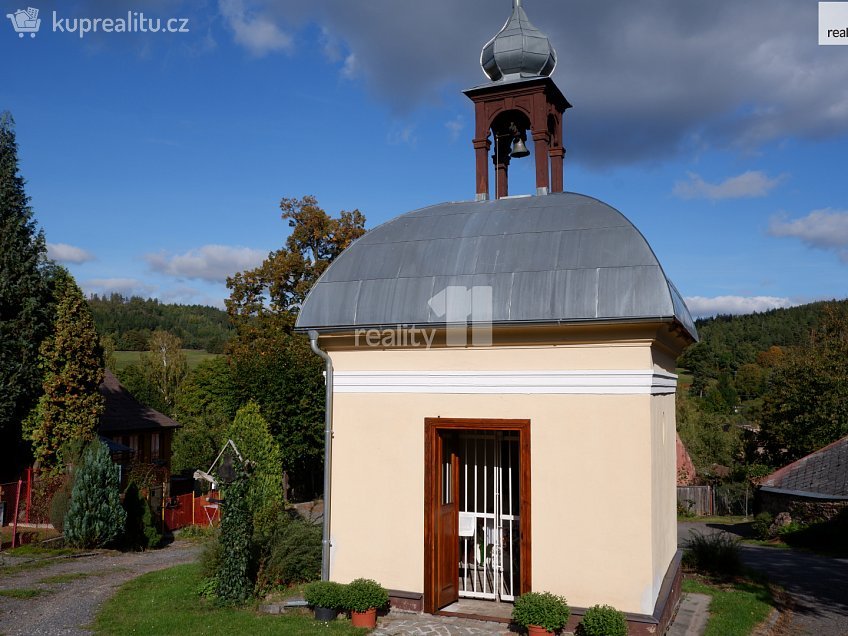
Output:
[{"xmin": 256, "ymin": 509, "xmax": 321, "ymax": 593}]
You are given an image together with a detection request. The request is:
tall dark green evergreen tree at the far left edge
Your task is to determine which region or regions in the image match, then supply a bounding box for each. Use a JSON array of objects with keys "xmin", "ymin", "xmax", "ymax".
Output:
[{"xmin": 0, "ymin": 113, "xmax": 51, "ymax": 480}]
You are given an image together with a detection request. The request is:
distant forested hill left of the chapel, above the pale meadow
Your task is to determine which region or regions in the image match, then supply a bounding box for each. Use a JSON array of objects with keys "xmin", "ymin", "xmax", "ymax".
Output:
[{"xmin": 88, "ymin": 294, "xmax": 233, "ymax": 353}]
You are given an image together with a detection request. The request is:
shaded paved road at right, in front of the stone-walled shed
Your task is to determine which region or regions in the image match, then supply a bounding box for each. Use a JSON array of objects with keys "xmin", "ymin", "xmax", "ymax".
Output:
[{"xmin": 677, "ymin": 522, "xmax": 848, "ymax": 636}]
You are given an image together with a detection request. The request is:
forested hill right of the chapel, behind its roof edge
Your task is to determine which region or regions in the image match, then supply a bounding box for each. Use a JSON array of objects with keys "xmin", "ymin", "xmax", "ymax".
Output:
[{"xmin": 677, "ymin": 300, "xmax": 848, "ymax": 392}]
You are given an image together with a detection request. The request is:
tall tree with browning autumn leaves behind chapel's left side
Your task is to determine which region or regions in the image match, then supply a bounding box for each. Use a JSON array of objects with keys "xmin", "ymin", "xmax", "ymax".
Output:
[{"xmin": 226, "ymin": 196, "xmax": 365, "ymax": 494}]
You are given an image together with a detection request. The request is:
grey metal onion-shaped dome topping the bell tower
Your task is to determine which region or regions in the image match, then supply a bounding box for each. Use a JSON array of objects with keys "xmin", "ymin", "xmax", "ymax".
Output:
[{"xmin": 480, "ymin": 0, "xmax": 556, "ymax": 82}]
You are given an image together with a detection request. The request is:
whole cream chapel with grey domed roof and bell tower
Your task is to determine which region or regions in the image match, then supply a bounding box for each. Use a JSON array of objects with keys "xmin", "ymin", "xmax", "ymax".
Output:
[{"xmin": 296, "ymin": 0, "xmax": 697, "ymax": 636}]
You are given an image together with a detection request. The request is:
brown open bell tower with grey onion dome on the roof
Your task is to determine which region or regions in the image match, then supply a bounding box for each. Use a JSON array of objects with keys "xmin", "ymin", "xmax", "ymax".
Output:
[{"xmin": 463, "ymin": 0, "xmax": 571, "ymax": 201}]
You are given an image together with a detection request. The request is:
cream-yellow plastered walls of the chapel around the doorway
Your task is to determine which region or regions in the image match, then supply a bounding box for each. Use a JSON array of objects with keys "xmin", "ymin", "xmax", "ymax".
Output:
[{"xmin": 324, "ymin": 343, "xmax": 676, "ymax": 614}]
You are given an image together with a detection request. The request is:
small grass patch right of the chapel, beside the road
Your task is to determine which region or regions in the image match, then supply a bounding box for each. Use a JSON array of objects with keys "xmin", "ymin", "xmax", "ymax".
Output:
[{"xmin": 683, "ymin": 577, "xmax": 774, "ymax": 636}]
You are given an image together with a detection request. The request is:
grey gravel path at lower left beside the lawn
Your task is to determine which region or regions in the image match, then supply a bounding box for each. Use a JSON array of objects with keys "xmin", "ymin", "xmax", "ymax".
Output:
[{"xmin": 0, "ymin": 541, "xmax": 200, "ymax": 636}]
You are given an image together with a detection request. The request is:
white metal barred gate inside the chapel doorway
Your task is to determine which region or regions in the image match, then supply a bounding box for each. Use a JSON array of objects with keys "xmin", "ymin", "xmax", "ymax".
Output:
[{"xmin": 455, "ymin": 431, "xmax": 521, "ymax": 601}]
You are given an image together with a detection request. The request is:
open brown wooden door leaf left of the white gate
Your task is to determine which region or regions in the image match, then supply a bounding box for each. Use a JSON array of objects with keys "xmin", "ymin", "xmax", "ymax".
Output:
[{"xmin": 435, "ymin": 434, "xmax": 459, "ymax": 608}]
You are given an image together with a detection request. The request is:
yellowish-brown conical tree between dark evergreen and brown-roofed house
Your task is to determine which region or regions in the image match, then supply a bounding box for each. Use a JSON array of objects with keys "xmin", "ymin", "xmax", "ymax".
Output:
[{"xmin": 28, "ymin": 268, "xmax": 103, "ymax": 469}]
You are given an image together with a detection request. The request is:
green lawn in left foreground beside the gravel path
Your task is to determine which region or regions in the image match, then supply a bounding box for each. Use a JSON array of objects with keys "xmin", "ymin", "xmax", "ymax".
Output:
[{"xmin": 93, "ymin": 563, "xmax": 366, "ymax": 636}]
